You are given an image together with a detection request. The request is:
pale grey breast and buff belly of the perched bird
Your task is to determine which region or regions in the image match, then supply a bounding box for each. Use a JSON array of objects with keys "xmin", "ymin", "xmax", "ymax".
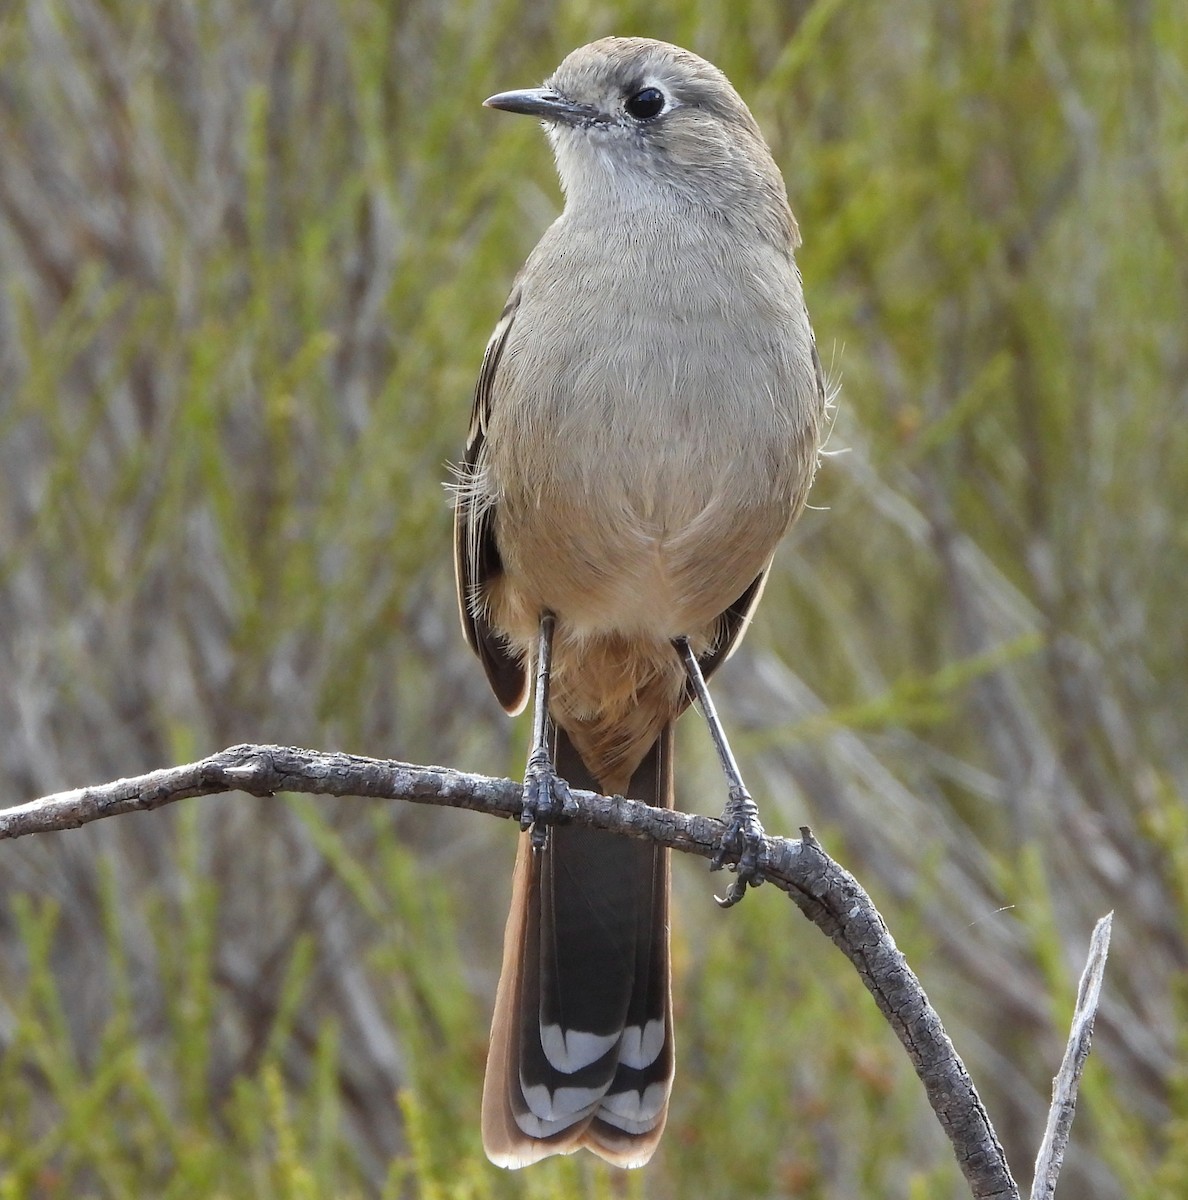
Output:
[{"xmin": 488, "ymin": 219, "xmax": 816, "ymax": 638}]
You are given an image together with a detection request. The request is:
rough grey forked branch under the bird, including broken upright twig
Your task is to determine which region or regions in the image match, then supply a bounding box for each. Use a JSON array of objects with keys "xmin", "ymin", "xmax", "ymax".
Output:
[{"xmin": 0, "ymin": 745, "xmax": 1108, "ymax": 1200}]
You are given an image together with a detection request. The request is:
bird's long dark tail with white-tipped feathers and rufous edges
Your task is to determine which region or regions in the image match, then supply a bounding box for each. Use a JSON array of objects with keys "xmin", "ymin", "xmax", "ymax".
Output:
[{"xmin": 482, "ymin": 725, "xmax": 673, "ymax": 1166}]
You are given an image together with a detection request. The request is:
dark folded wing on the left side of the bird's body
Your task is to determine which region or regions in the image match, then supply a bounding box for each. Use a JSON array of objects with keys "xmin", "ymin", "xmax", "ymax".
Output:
[{"xmin": 454, "ymin": 284, "xmax": 528, "ymax": 713}]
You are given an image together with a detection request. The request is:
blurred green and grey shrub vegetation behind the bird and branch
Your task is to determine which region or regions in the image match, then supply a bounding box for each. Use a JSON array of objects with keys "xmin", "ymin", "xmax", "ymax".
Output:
[{"xmin": 0, "ymin": 0, "xmax": 1188, "ymax": 1200}]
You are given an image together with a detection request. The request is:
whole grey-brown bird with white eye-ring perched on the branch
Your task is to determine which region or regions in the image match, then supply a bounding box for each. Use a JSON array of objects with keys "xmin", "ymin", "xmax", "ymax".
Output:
[{"xmin": 454, "ymin": 37, "xmax": 828, "ymax": 1168}]
